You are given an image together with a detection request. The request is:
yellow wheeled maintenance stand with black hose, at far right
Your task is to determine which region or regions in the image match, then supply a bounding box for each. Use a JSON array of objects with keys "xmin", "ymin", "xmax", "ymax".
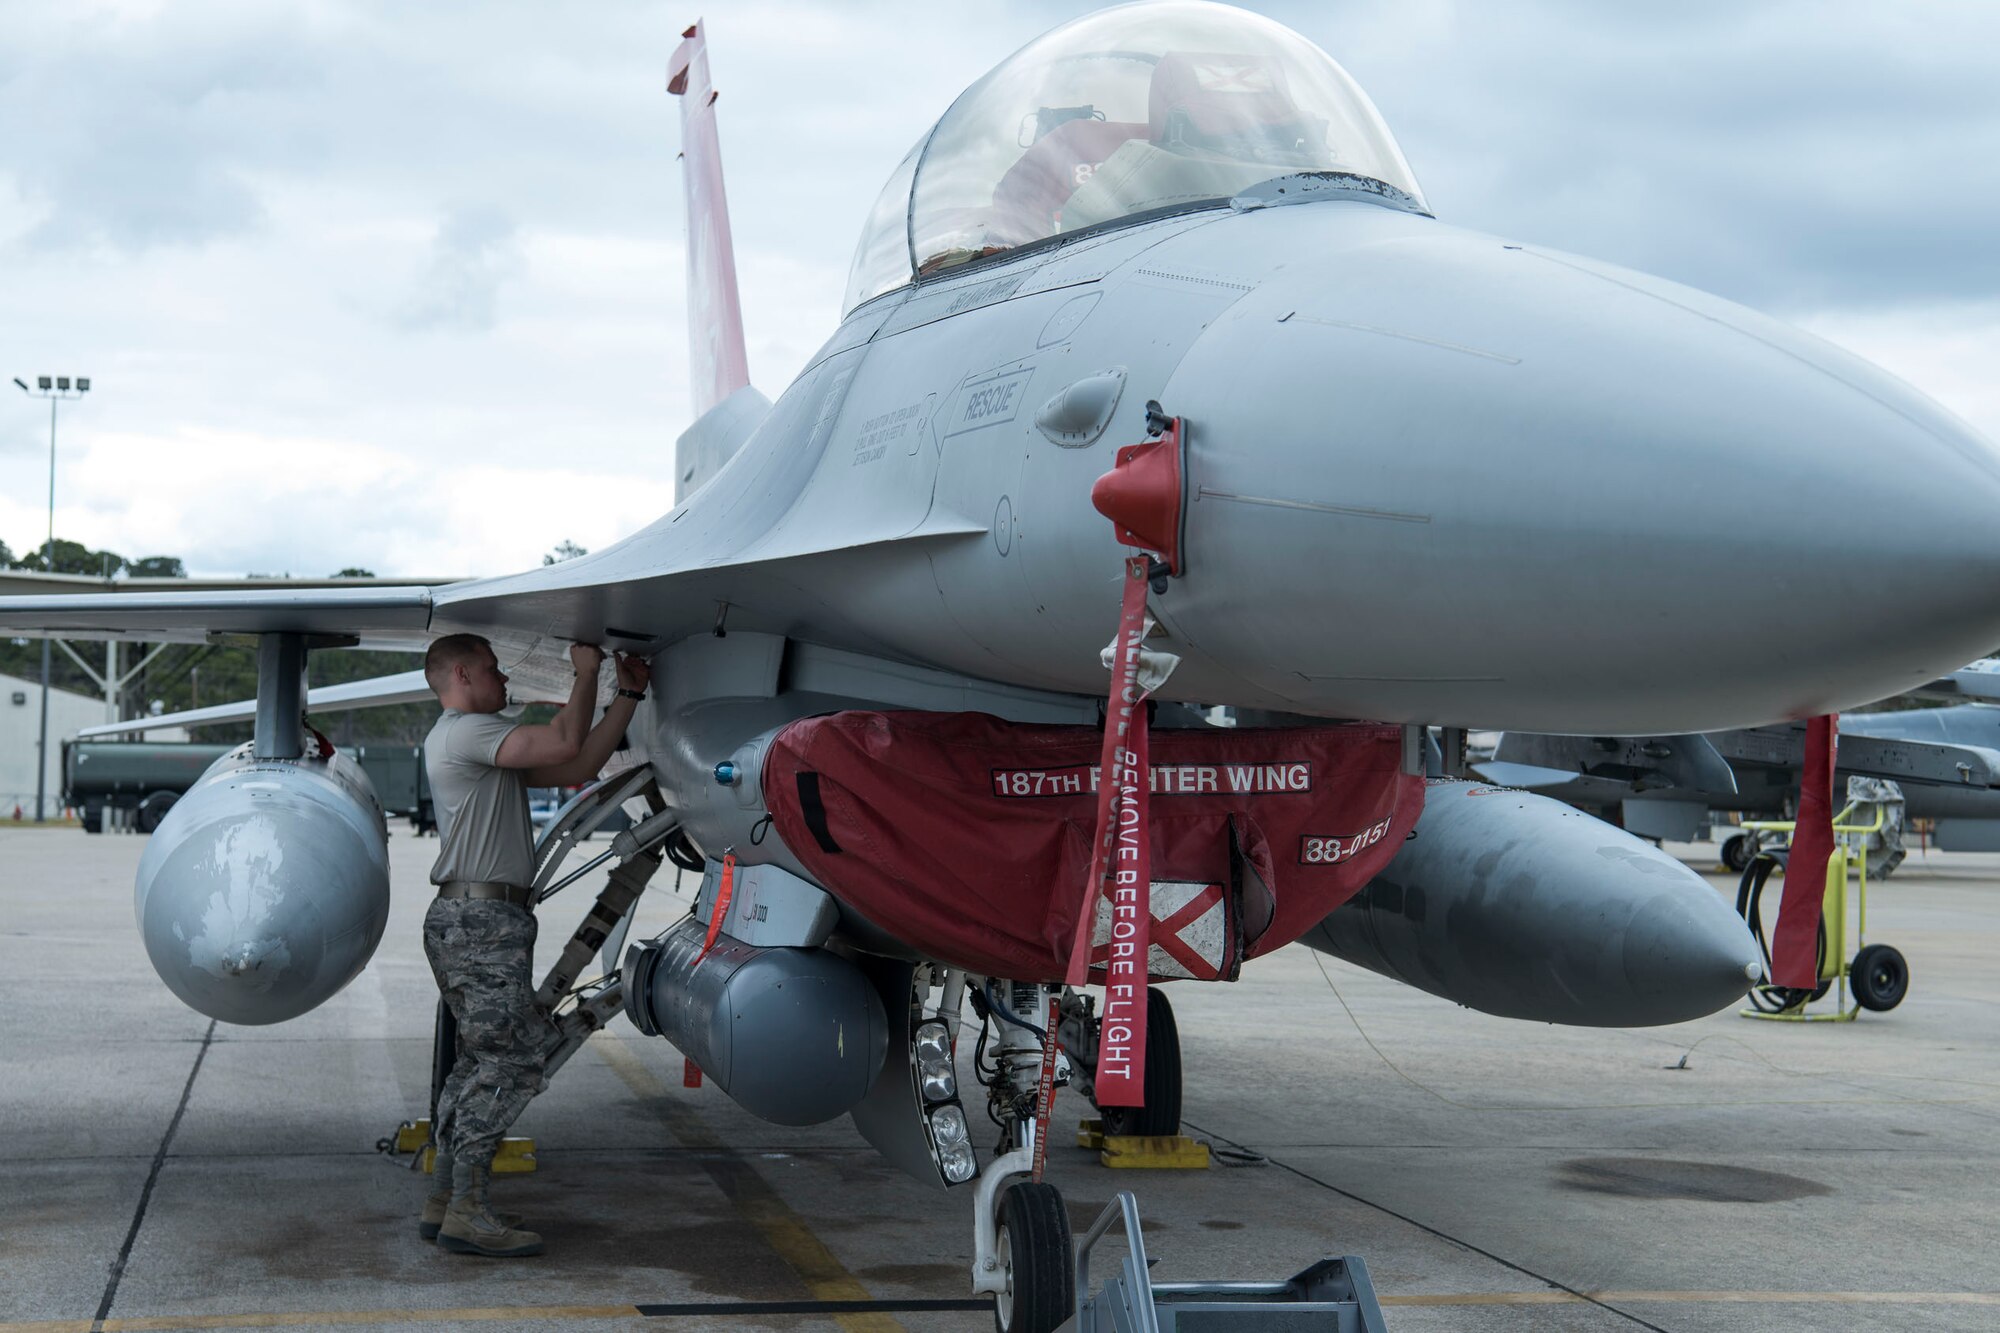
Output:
[{"xmin": 1736, "ymin": 801, "xmax": 1910, "ymax": 1023}]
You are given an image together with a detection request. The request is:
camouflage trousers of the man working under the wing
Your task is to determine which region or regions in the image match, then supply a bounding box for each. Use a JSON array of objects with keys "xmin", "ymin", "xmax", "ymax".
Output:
[{"xmin": 424, "ymin": 899, "xmax": 556, "ymax": 1167}]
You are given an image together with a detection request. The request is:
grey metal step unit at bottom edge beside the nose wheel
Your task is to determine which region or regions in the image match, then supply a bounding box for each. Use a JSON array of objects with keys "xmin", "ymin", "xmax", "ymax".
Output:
[{"xmin": 1058, "ymin": 1189, "xmax": 1388, "ymax": 1333}]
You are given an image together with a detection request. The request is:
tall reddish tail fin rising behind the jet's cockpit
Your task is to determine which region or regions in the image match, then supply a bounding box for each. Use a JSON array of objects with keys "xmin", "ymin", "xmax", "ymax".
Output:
[{"xmin": 666, "ymin": 22, "xmax": 750, "ymax": 416}]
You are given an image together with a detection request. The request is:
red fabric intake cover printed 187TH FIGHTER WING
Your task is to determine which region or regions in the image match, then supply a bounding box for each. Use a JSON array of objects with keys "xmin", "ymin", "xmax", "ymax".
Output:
[{"xmin": 764, "ymin": 713, "xmax": 1424, "ymax": 983}]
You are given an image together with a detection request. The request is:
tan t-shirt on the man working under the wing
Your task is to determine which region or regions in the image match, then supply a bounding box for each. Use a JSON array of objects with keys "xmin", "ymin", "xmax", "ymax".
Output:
[{"xmin": 424, "ymin": 709, "xmax": 534, "ymax": 885}]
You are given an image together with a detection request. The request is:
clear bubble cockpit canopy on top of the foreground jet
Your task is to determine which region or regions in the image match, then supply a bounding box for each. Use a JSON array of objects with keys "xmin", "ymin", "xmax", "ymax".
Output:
[{"xmin": 842, "ymin": 2, "xmax": 1424, "ymax": 310}]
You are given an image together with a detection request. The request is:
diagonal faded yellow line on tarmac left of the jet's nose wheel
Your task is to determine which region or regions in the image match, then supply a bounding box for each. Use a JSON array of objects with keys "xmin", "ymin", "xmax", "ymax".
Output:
[{"xmin": 592, "ymin": 1031, "xmax": 904, "ymax": 1333}]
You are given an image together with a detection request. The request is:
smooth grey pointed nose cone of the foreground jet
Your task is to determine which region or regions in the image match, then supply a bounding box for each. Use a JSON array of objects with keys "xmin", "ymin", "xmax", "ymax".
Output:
[{"xmin": 1162, "ymin": 206, "xmax": 2000, "ymax": 735}]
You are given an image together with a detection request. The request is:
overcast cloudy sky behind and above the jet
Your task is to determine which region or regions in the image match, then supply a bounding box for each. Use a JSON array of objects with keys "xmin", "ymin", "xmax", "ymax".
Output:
[{"xmin": 0, "ymin": 0, "xmax": 2000, "ymax": 574}]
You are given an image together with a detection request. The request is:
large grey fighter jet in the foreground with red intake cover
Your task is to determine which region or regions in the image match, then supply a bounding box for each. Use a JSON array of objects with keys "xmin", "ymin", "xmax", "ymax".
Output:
[{"xmin": 0, "ymin": 4, "xmax": 2000, "ymax": 1329}]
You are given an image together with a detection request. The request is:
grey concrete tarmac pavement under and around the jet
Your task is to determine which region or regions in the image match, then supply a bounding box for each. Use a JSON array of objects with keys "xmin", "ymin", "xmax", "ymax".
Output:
[{"xmin": 0, "ymin": 827, "xmax": 2000, "ymax": 1333}]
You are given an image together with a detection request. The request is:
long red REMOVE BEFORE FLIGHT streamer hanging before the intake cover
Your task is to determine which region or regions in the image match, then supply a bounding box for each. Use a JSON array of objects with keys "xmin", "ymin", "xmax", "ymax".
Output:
[{"xmin": 1068, "ymin": 556, "xmax": 1152, "ymax": 1107}]
